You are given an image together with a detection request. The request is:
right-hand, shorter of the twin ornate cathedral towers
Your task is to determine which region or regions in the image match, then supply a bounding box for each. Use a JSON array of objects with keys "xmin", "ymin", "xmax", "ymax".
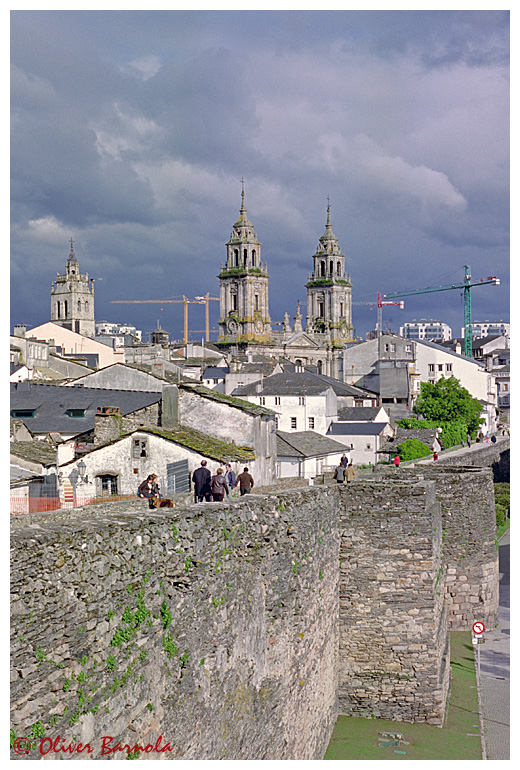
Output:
[{"xmin": 305, "ymin": 206, "xmax": 352, "ymax": 347}]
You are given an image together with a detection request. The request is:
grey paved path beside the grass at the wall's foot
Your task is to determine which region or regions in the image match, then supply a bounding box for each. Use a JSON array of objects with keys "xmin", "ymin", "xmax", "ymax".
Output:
[{"xmin": 479, "ymin": 530, "xmax": 510, "ymax": 760}]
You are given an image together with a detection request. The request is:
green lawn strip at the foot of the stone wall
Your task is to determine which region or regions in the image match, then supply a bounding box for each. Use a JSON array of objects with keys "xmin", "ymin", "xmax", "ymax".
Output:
[{"xmin": 324, "ymin": 631, "xmax": 482, "ymax": 760}]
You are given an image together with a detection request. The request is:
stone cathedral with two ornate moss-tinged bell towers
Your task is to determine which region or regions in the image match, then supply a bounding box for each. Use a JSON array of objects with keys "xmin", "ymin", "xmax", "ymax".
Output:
[{"xmin": 217, "ymin": 189, "xmax": 353, "ymax": 377}]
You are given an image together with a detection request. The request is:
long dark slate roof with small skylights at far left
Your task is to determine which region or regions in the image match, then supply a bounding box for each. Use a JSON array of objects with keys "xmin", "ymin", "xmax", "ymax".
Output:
[{"xmin": 11, "ymin": 382, "xmax": 162, "ymax": 436}]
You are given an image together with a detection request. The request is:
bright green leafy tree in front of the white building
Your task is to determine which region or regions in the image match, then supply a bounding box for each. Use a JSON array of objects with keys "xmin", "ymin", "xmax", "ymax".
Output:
[{"xmin": 413, "ymin": 377, "xmax": 484, "ymax": 433}]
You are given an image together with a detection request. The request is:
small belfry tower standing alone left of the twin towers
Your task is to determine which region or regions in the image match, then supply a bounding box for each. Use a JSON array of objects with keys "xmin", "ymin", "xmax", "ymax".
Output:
[{"xmin": 51, "ymin": 238, "xmax": 96, "ymax": 337}]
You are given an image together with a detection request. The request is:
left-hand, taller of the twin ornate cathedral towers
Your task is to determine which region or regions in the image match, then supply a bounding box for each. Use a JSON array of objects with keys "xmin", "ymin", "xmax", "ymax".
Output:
[{"xmin": 218, "ymin": 185, "xmax": 271, "ymax": 344}]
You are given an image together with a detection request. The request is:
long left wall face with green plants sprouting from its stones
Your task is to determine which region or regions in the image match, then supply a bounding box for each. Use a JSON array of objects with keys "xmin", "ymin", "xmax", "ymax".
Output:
[{"xmin": 11, "ymin": 488, "xmax": 338, "ymax": 760}]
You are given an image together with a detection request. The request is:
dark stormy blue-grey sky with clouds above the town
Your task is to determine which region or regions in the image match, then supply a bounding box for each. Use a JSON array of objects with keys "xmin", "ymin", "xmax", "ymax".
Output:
[{"xmin": 11, "ymin": 10, "xmax": 509, "ymax": 340}]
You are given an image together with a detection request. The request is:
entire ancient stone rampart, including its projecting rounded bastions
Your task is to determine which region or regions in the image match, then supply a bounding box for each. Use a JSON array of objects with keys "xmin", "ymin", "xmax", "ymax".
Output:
[{"xmin": 11, "ymin": 467, "xmax": 498, "ymax": 760}]
